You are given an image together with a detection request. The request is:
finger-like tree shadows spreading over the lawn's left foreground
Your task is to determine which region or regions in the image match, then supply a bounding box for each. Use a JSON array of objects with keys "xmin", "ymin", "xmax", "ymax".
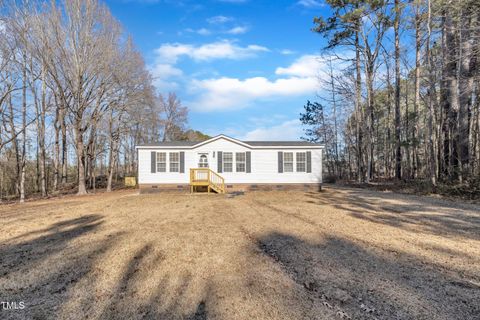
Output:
[{"xmin": 0, "ymin": 214, "xmax": 207, "ymax": 320}]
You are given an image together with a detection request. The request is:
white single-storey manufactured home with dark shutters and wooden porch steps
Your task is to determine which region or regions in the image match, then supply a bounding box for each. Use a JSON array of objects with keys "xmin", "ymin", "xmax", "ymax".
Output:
[{"xmin": 136, "ymin": 135, "xmax": 323, "ymax": 193}]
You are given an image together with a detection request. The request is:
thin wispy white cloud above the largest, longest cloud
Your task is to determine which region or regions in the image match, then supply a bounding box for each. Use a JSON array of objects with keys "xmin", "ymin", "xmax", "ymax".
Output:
[{"xmin": 155, "ymin": 40, "xmax": 269, "ymax": 64}]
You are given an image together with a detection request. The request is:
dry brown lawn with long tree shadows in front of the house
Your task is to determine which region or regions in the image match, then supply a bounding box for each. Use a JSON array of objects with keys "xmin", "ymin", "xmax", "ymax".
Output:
[{"xmin": 0, "ymin": 187, "xmax": 480, "ymax": 320}]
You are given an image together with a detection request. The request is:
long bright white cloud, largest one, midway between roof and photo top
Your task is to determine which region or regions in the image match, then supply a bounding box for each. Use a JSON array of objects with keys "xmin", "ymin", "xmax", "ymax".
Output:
[{"xmin": 189, "ymin": 77, "xmax": 318, "ymax": 112}]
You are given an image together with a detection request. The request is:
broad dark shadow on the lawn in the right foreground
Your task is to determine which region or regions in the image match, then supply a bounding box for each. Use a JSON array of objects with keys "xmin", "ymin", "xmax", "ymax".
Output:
[{"xmin": 258, "ymin": 233, "xmax": 480, "ymax": 320}]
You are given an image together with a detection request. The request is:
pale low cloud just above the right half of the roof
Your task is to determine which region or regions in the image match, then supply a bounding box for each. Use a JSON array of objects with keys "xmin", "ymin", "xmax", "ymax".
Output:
[{"xmin": 238, "ymin": 119, "xmax": 303, "ymax": 141}]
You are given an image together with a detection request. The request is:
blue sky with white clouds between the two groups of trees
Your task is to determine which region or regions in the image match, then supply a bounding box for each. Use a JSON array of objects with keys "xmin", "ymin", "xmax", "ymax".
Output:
[{"xmin": 107, "ymin": 0, "xmax": 327, "ymax": 140}]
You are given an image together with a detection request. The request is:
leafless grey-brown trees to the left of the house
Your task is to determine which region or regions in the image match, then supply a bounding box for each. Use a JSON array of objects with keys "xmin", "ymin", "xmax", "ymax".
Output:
[{"xmin": 0, "ymin": 0, "xmax": 201, "ymax": 202}]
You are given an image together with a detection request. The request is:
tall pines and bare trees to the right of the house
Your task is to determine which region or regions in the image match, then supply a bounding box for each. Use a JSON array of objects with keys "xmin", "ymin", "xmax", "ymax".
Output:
[{"xmin": 301, "ymin": 0, "xmax": 480, "ymax": 187}]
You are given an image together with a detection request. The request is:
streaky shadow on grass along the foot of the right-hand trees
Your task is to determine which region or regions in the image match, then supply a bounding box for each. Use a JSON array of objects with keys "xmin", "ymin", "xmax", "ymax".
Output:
[{"xmin": 306, "ymin": 189, "xmax": 480, "ymax": 240}]
